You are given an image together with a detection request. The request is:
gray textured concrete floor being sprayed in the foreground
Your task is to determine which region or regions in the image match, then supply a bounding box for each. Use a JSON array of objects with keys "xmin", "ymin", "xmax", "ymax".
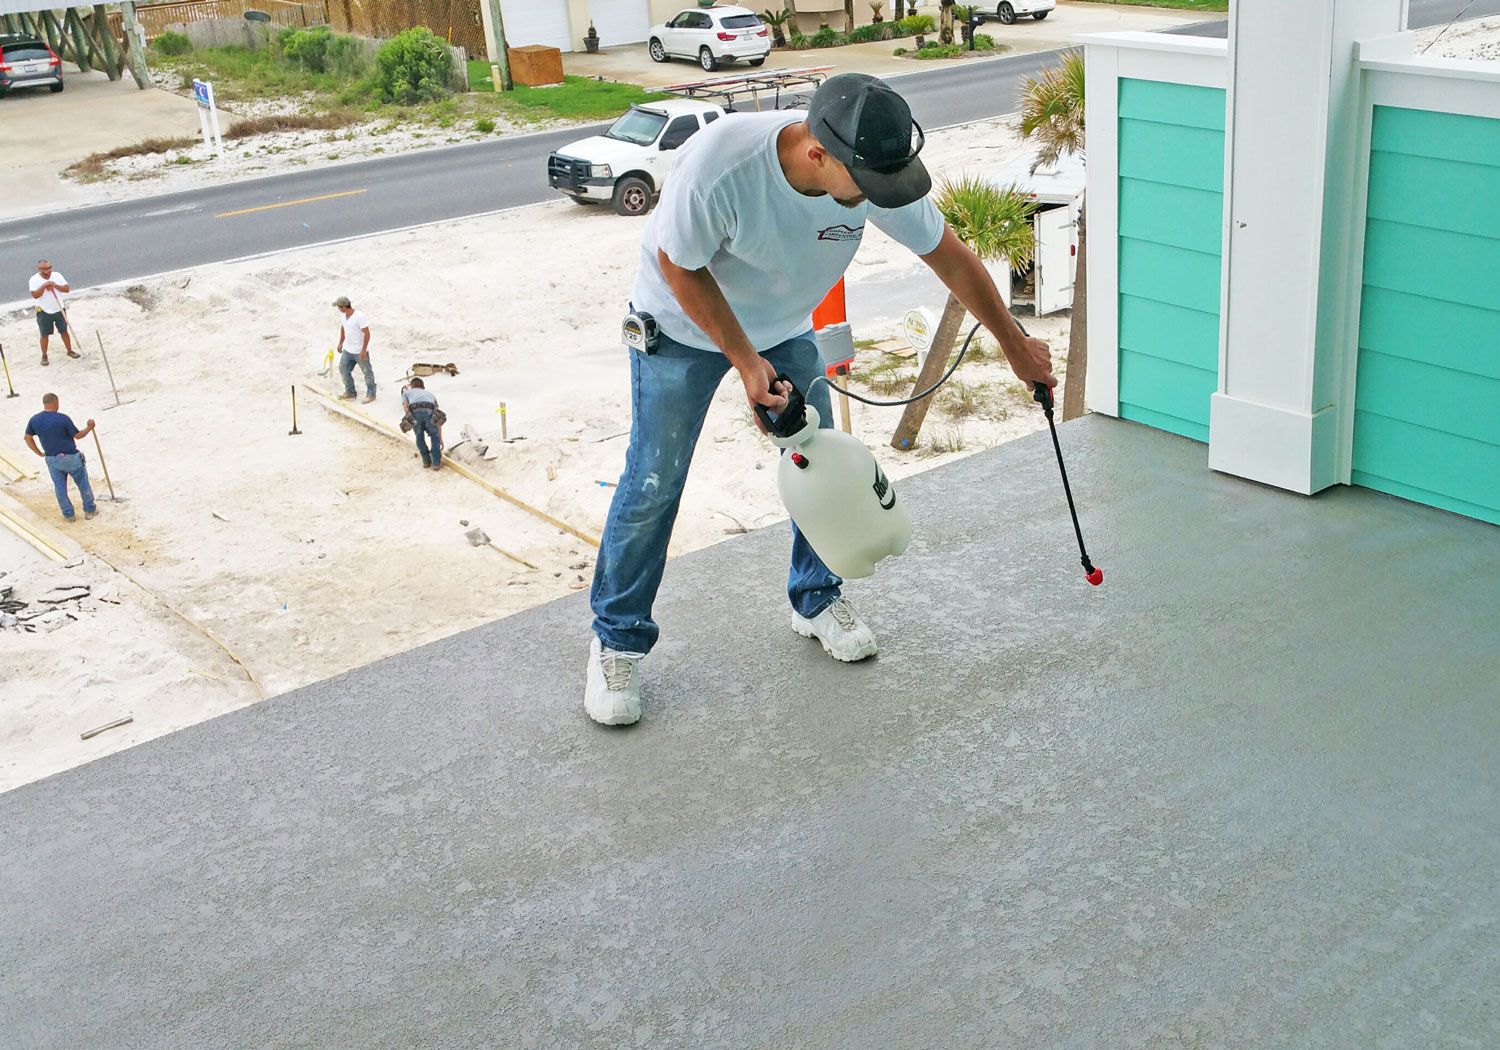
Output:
[{"xmin": 0, "ymin": 419, "xmax": 1500, "ymax": 1049}]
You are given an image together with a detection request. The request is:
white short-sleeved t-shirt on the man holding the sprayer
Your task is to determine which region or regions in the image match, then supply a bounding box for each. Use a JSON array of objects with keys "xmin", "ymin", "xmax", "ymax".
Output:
[{"xmin": 632, "ymin": 111, "xmax": 944, "ymax": 351}]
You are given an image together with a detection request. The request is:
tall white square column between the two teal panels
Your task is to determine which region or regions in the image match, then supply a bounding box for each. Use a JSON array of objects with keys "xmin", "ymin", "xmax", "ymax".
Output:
[{"xmin": 1209, "ymin": 0, "xmax": 1407, "ymax": 494}]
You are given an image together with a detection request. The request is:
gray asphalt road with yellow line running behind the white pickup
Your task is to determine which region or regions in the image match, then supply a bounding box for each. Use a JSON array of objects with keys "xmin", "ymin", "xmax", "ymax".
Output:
[{"xmin": 0, "ymin": 0, "xmax": 1500, "ymax": 288}]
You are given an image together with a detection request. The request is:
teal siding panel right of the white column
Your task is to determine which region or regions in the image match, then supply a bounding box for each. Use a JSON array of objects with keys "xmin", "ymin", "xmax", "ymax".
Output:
[{"xmin": 1352, "ymin": 107, "xmax": 1500, "ymax": 524}]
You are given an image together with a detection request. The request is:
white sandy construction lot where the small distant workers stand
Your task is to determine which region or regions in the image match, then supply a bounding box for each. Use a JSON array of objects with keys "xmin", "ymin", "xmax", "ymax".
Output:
[{"xmin": 0, "ymin": 122, "xmax": 1068, "ymax": 789}]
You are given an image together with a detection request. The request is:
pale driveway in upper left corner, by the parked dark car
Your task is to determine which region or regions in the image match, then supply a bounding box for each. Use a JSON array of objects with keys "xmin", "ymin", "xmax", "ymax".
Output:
[{"xmin": 0, "ymin": 66, "xmax": 200, "ymax": 216}]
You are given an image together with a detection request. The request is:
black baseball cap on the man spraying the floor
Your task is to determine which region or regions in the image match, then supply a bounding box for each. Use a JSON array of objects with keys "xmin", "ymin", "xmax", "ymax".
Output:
[{"xmin": 807, "ymin": 74, "xmax": 933, "ymax": 209}]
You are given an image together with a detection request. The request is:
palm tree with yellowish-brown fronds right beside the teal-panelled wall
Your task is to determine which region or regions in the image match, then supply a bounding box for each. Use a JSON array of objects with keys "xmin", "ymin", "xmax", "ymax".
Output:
[{"xmin": 1020, "ymin": 51, "xmax": 1089, "ymax": 420}]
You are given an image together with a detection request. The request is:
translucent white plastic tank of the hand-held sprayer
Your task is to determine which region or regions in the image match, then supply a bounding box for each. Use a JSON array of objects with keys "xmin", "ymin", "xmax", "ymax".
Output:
[{"xmin": 771, "ymin": 405, "xmax": 912, "ymax": 579}]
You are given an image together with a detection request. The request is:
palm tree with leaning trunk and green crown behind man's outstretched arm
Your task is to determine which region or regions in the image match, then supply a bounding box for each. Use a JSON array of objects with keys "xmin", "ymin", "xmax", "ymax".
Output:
[{"xmin": 891, "ymin": 176, "xmax": 1037, "ymax": 452}]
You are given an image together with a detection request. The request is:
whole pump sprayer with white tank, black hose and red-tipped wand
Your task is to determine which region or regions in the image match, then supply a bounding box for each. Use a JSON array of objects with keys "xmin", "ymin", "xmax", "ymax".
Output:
[{"xmin": 756, "ymin": 321, "xmax": 1104, "ymax": 587}]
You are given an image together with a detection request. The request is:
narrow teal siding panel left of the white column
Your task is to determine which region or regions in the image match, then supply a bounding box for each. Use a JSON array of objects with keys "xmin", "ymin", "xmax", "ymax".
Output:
[{"xmin": 1118, "ymin": 80, "xmax": 1224, "ymax": 441}]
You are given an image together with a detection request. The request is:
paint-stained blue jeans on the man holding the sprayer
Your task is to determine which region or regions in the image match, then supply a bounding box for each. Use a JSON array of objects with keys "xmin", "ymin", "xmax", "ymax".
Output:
[{"xmin": 590, "ymin": 332, "xmax": 843, "ymax": 653}]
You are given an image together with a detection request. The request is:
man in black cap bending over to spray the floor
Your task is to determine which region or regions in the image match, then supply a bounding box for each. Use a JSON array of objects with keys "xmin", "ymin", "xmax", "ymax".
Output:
[{"xmin": 584, "ymin": 74, "xmax": 1056, "ymax": 726}]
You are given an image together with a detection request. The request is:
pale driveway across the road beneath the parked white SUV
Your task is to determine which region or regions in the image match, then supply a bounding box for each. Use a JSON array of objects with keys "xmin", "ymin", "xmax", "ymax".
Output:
[{"xmin": 563, "ymin": 3, "xmax": 1223, "ymax": 87}]
